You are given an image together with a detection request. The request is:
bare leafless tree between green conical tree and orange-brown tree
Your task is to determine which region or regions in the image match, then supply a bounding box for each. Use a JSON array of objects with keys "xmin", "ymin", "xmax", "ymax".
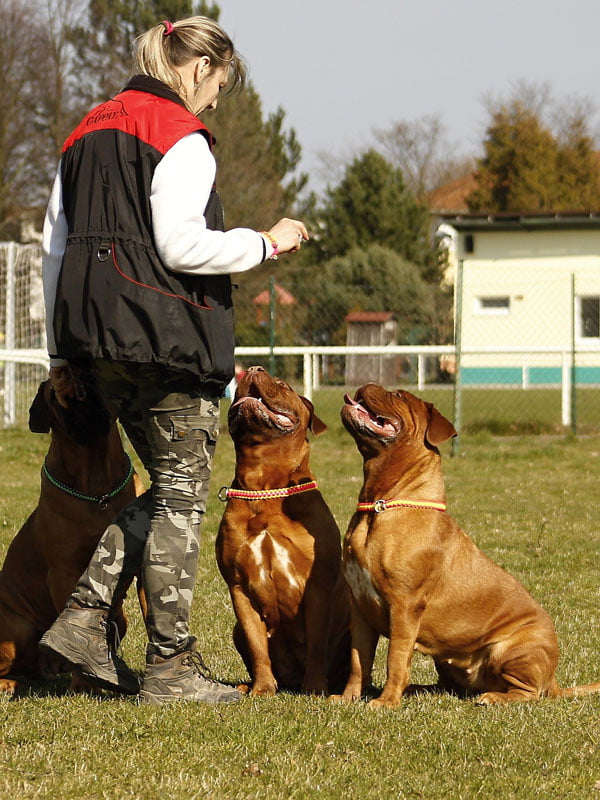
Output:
[{"xmin": 375, "ymin": 114, "xmax": 473, "ymax": 202}]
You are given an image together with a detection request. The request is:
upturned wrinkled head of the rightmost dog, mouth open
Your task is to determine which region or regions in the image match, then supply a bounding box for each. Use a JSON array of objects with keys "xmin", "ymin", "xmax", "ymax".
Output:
[{"xmin": 342, "ymin": 383, "xmax": 456, "ymax": 454}]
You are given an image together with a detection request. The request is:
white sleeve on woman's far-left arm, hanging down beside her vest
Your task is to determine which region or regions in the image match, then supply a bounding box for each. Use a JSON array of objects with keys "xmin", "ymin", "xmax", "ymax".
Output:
[{"xmin": 42, "ymin": 164, "xmax": 68, "ymax": 366}]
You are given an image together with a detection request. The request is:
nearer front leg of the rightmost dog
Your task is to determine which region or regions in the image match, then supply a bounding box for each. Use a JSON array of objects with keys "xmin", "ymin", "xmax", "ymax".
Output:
[{"xmin": 369, "ymin": 602, "xmax": 420, "ymax": 708}]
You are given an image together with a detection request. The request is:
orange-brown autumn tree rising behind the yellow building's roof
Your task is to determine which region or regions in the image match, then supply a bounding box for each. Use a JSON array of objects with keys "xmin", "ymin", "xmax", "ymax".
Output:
[{"xmin": 467, "ymin": 87, "xmax": 600, "ymax": 212}]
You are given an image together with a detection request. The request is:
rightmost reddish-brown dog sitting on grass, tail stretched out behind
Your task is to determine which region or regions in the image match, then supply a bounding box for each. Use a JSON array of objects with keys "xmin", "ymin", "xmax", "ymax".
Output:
[{"xmin": 342, "ymin": 383, "xmax": 600, "ymax": 708}]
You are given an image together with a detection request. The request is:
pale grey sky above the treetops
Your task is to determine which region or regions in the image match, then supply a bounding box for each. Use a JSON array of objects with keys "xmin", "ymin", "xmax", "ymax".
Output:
[{"xmin": 219, "ymin": 0, "xmax": 600, "ymax": 191}]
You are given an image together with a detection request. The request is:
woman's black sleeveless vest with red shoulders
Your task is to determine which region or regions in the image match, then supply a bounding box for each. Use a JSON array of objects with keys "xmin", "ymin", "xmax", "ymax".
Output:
[{"xmin": 53, "ymin": 75, "xmax": 234, "ymax": 392}]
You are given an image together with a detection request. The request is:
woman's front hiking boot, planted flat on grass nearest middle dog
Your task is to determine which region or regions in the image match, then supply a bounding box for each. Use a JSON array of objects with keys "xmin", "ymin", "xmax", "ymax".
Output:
[{"xmin": 140, "ymin": 646, "xmax": 242, "ymax": 706}]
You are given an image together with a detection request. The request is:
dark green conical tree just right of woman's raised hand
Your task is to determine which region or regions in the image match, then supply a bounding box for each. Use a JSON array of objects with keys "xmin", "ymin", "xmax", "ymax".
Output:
[{"xmin": 315, "ymin": 149, "xmax": 440, "ymax": 281}]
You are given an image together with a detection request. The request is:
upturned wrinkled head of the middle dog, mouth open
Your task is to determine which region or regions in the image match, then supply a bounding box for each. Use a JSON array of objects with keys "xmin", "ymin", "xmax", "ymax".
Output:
[{"xmin": 228, "ymin": 367, "xmax": 325, "ymax": 439}]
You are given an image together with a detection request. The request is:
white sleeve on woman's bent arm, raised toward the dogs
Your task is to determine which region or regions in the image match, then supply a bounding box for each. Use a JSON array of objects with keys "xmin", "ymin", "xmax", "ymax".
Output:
[{"xmin": 150, "ymin": 133, "xmax": 270, "ymax": 275}]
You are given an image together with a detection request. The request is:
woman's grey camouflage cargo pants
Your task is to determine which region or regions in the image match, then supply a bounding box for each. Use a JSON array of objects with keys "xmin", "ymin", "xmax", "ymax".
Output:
[{"xmin": 73, "ymin": 361, "xmax": 219, "ymax": 657}]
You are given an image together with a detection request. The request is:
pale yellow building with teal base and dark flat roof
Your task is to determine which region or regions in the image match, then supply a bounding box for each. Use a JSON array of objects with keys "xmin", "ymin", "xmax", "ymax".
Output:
[{"xmin": 437, "ymin": 213, "xmax": 600, "ymax": 386}]
